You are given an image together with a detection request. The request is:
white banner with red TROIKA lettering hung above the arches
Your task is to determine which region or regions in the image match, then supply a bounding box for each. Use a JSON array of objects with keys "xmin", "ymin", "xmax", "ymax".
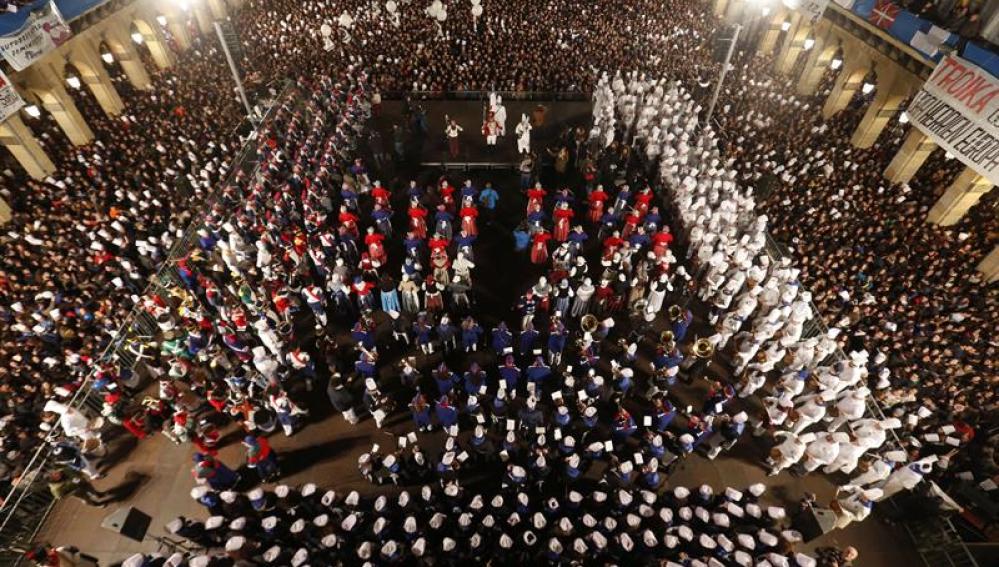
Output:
[{"xmin": 906, "ymin": 55, "xmax": 999, "ymax": 185}]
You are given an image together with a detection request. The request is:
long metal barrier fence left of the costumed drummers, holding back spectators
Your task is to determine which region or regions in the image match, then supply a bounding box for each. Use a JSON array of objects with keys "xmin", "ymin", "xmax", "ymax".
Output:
[{"xmin": 0, "ymin": 81, "xmax": 294, "ymax": 566}]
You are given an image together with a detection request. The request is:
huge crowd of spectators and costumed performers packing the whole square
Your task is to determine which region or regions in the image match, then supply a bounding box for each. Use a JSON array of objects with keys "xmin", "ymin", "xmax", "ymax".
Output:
[{"xmin": 0, "ymin": 0, "xmax": 999, "ymax": 567}]
